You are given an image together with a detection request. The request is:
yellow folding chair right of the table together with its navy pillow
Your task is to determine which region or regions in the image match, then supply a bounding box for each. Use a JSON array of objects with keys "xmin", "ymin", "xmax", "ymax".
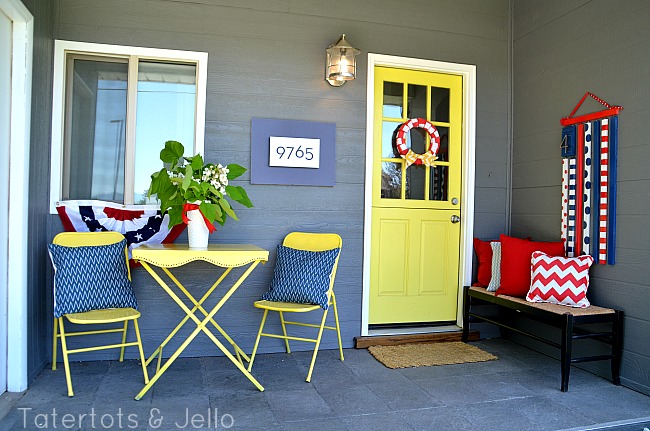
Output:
[{"xmin": 248, "ymin": 232, "xmax": 344, "ymax": 382}]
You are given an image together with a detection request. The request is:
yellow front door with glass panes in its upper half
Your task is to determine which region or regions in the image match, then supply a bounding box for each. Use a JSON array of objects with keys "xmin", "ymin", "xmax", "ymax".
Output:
[{"xmin": 369, "ymin": 67, "xmax": 463, "ymax": 324}]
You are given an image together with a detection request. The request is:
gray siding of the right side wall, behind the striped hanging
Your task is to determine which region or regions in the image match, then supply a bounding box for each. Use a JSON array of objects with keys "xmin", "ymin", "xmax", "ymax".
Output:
[{"xmin": 512, "ymin": 0, "xmax": 650, "ymax": 393}]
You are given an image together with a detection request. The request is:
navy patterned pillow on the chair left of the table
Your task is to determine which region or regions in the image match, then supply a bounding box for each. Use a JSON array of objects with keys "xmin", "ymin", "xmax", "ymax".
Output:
[{"xmin": 48, "ymin": 239, "xmax": 138, "ymax": 317}]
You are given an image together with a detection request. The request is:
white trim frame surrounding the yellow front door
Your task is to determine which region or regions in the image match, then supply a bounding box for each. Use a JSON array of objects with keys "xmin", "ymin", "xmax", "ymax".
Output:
[{"xmin": 361, "ymin": 53, "xmax": 476, "ymax": 336}]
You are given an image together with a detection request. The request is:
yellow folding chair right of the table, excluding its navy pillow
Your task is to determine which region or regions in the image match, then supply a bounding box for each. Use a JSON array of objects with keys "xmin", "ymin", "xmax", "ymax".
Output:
[{"xmin": 248, "ymin": 232, "xmax": 344, "ymax": 382}]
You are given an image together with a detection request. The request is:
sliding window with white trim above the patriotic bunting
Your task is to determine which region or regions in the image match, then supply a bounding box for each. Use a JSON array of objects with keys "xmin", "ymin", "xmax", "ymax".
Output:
[{"xmin": 50, "ymin": 40, "xmax": 208, "ymax": 213}]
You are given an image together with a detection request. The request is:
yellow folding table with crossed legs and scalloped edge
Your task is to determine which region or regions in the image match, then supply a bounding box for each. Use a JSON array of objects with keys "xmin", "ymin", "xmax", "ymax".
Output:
[{"xmin": 132, "ymin": 244, "xmax": 269, "ymax": 400}]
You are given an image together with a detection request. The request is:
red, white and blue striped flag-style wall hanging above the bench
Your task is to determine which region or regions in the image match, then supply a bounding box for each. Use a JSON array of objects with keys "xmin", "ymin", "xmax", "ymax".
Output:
[{"xmin": 560, "ymin": 92, "xmax": 623, "ymax": 265}]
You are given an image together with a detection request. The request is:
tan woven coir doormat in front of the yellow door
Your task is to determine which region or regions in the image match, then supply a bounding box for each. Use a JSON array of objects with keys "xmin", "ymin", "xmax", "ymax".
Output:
[{"xmin": 368, "ymin": 341, "xmax": 498, "ymax": 368}]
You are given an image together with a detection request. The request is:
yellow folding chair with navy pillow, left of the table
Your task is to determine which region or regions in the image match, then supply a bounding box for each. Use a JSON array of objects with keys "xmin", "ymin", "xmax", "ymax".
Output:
[{"xmin": 50, "ymin": 232, "xmax": 149, "ymax": 397}]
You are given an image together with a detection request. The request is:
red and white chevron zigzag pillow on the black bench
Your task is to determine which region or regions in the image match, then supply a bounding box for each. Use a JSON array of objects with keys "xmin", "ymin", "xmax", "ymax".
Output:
[{"xmin": 526, "ymin": 251, "xmax": 594, "ymax": 308}]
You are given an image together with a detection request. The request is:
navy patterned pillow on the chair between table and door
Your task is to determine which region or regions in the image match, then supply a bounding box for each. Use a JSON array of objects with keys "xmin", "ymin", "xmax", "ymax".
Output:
[{"xmin": 262, "ymin": 245, "xmax": 341, "ymax": 310}]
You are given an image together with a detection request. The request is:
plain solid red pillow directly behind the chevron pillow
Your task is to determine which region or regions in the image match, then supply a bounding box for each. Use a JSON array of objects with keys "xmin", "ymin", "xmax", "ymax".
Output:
[{"xmin": 496, "ymin": 235, "xmax": 564, "ymax": 298}]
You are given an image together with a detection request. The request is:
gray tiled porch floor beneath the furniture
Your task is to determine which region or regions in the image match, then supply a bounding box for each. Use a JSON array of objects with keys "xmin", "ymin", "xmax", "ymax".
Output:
[{"xmin": 0, "ymin": 339, "xmax": 650, "ymax": 431}]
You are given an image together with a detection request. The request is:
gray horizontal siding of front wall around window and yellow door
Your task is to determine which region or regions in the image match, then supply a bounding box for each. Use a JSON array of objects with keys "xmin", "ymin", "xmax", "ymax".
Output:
[{"xmin": 30, "ymin": 0, "xmax": 510, "ymax": 384}]
